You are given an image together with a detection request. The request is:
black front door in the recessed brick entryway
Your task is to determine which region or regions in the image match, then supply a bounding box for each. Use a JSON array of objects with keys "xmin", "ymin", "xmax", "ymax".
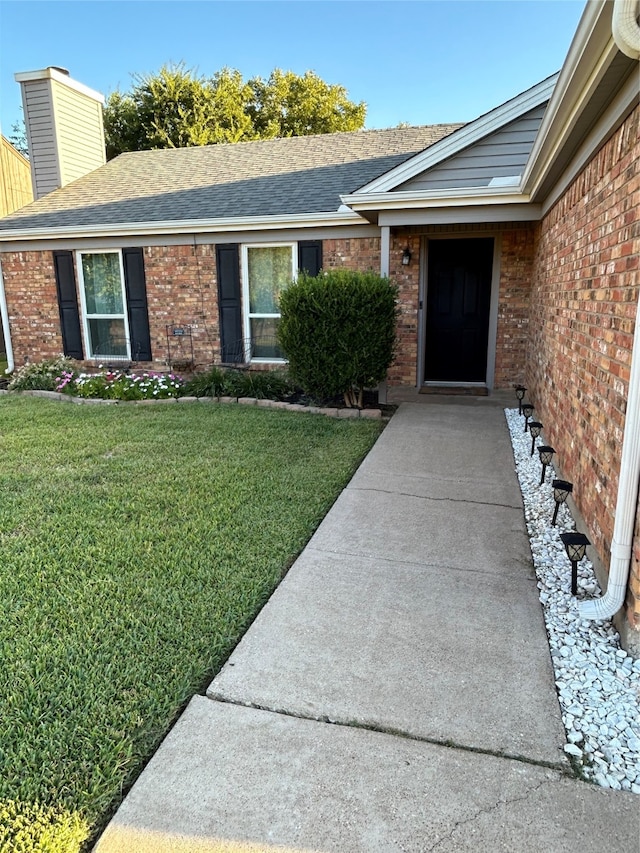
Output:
[{"xmin": 424, "ymin": 237, "xmax": 493, "ymax": 382}]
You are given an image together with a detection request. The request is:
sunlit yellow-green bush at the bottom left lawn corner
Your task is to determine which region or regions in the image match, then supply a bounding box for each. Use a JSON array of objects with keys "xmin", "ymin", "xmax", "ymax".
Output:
[{"xmin": 0, "ymin": 800, "xmax": 89, "ymax": 853}]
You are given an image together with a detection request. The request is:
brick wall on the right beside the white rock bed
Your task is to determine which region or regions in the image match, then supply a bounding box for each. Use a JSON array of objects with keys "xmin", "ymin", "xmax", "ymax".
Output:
[{"xmin": 525, "ymin": 103, "xmax": 640, "ymax": 628}]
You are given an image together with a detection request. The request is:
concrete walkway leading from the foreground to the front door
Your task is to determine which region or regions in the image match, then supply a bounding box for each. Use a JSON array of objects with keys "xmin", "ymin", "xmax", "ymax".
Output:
[{"xmin": 97, "ymin": 396, "xmax": 640, "ymax": 853}]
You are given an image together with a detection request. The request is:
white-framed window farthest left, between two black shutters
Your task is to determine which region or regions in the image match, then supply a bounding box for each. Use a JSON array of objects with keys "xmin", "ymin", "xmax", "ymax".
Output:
[{"xmin": 78, "ymin": 251, "xmax": 131, "ymax": 359}]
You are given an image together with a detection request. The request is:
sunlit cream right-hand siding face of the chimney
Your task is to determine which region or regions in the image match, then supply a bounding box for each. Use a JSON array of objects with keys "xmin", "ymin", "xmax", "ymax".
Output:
[{"xmin": 52, "ymin": 80, "xmax": 105, "ymax": 186}]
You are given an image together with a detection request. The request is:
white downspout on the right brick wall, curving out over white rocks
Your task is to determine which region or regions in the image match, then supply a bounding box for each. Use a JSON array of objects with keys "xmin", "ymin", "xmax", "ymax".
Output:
[{"xmin": 578, "ymin": 290, "xmax": 640, "ymax": 619}]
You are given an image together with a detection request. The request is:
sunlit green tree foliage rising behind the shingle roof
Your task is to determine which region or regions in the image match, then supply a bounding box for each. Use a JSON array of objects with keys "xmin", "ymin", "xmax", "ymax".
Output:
[{"xmin": 104, "ymin": 63, "xmax": 366, "ymax": 159}]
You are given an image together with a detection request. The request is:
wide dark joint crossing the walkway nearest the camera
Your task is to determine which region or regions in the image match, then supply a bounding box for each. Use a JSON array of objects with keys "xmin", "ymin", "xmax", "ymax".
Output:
[{"xmin": 206, "ymin": 693, "xmax": 576, "ymax": 776}]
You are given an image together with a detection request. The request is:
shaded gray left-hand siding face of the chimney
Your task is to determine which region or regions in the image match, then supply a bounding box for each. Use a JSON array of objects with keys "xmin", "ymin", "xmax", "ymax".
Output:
[{"xmin": 22, "ymin": 80, "xmax": 60, "ymax": 198}]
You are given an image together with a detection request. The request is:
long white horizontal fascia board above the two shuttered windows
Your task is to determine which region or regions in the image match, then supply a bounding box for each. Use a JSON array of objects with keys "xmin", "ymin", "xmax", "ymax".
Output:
[{"xmin": 0, "ymin": 210, "xmax": 363, "ymax": 243}]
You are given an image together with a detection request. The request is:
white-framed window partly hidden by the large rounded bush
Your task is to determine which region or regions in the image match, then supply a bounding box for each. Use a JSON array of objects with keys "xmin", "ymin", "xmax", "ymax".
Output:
[{"xmin": 242, "ymin": 243, "xmax": 296, "ymax": 361}]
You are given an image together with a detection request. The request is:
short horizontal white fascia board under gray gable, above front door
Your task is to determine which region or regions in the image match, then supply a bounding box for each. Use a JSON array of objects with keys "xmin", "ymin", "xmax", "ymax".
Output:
[{"xmin": 341, "ymin": 186, "xmax": 530, "ymax": 210}]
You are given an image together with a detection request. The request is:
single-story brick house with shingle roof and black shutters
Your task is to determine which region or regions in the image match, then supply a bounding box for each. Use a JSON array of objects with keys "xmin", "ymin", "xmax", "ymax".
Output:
[{"xmin": 0, "ymin": 0, "xmax": 640, "ymax": 653}]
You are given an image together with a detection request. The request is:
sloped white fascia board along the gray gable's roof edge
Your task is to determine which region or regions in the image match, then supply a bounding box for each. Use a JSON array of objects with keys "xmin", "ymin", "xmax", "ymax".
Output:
[{"xmin": 354, "ymin": 74, "xmax": 558, "ymax": 195}]
